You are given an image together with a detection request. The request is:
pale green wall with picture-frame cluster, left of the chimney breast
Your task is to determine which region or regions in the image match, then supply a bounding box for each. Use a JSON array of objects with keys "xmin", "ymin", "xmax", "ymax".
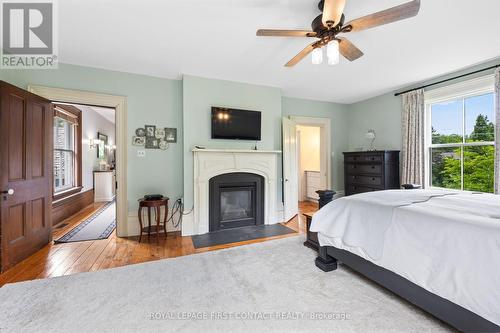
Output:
[{"xmin": 0, "ymin": 64, "xmax": 183, "ymax": 211}]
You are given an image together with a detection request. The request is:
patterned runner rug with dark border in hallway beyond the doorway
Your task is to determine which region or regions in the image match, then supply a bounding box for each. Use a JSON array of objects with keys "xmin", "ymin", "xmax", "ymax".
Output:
[{"xmin": 54, "ymin": 201, "xmax": 116, "ymax": 244}]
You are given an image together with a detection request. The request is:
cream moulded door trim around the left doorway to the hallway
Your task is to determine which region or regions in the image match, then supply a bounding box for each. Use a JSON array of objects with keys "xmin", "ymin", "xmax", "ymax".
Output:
[{"xmin": 28, "ymin": 85, "xmax": 129, "ymax": 237}]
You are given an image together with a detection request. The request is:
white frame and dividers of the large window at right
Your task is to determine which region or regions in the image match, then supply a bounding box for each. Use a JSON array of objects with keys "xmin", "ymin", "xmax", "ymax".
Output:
[{"xmin": 424, "ymin": 74, "xmax": 495, "ymax": 192}]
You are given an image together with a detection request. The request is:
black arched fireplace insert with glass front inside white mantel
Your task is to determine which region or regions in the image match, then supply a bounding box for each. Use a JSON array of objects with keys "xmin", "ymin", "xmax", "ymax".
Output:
[{"xmin": 209, "ymin": 172, "xmax": 264, "ymax": 232}]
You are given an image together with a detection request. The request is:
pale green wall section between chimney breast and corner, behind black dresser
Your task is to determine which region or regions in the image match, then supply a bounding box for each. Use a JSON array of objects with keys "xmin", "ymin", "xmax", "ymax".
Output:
[{"xmin": 281, "ymin": 97, "xmax": 349, "ymax": 191}]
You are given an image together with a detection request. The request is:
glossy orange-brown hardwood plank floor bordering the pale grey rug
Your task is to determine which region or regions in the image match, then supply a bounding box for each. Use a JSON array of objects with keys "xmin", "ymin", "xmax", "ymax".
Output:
[{"xmin": 0, "ymin": 202, "xmax": 317, "ymax": 287}]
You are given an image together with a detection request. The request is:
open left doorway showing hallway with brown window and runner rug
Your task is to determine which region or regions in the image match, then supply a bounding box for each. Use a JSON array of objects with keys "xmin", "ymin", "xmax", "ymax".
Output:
[{"xmin": 52, "ymin": 103, "xmax": 116, "ymax": 243}]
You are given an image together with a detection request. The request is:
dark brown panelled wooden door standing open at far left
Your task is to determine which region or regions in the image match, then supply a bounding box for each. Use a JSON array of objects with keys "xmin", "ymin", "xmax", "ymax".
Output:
[{"xmin": 0, "ymin": 81, "xmax": 53, "ymax": 271}]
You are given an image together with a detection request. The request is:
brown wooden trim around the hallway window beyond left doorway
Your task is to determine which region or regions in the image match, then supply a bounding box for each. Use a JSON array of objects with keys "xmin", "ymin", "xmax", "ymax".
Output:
[{"xmin": 52, "ymin": 103, "xmax": 83, "ymax": 202}]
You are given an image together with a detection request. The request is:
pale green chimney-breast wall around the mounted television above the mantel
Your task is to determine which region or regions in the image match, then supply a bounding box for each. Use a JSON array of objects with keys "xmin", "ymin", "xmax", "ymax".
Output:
[{"xmin": 183, "ymin": 75, "xmax": 281, "ymax": 209}]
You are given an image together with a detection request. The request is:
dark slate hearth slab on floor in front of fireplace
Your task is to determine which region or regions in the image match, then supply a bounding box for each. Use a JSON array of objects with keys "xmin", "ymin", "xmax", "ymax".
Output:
[{"xmin": 191, "ymin": 223, "xmax": 296, "ymax": 249}]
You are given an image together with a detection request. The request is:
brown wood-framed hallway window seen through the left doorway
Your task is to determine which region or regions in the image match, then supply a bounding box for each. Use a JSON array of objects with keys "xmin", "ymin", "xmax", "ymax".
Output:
[{"xmin": 53, "ymin": 105, "xmax": 81, "ymax": 200}]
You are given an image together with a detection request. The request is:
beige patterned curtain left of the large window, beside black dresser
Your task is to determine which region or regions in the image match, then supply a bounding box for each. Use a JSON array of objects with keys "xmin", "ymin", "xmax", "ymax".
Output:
[{"xmin": 401, "ymin": 89, "xmax": 425, "ymax": 187}]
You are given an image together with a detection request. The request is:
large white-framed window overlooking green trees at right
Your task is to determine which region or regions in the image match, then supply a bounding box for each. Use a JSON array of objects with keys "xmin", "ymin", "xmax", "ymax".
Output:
[{"xmin": 426, "ymin": 78, "xmax": 495, "ymax": 193}]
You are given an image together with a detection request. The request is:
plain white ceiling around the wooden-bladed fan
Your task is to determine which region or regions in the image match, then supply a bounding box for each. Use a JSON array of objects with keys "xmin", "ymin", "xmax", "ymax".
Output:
[{"xmin": 59, "ymin": 0, "xmax": 500, "ymax": 103}]
